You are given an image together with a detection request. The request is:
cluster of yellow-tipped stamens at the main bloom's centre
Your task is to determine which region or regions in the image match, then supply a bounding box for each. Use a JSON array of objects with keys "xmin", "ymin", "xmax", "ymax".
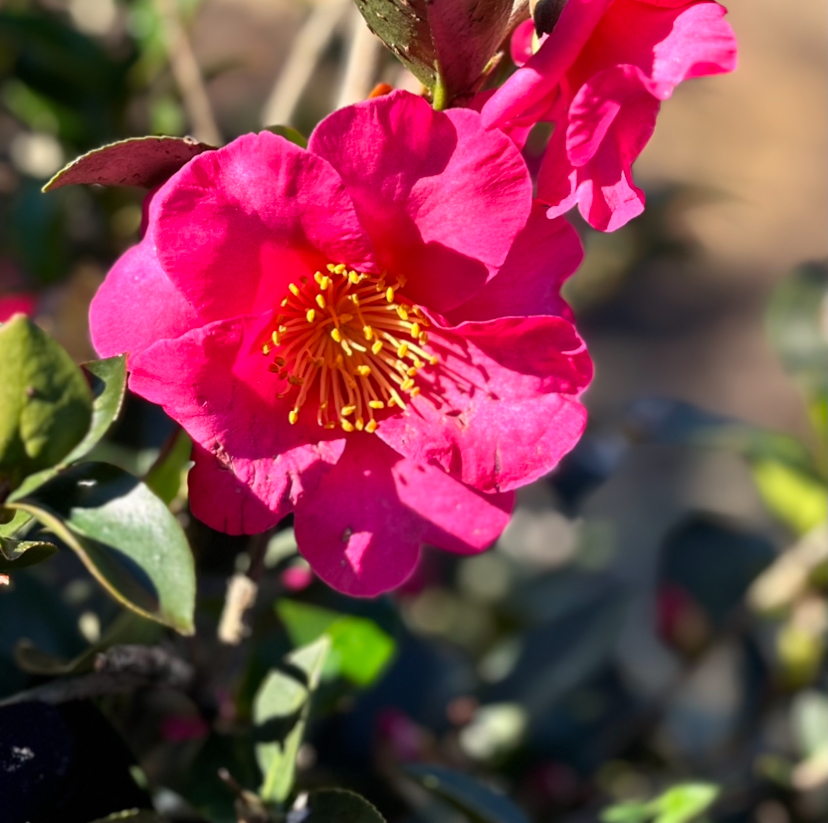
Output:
[{"xmin": 262, "ymin": 263, "xmax": 437, "ymax": 432}]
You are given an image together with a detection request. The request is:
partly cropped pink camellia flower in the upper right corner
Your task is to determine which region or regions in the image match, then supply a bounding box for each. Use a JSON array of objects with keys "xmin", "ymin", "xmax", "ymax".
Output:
[{"xmin": 482, "ymin": 0, "xmax": 736, "ymax": 231}]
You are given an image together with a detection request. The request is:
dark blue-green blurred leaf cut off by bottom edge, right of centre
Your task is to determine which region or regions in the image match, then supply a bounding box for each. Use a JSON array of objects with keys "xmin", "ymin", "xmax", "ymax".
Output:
[{"xmin": 404, "ymin": 764, "xmax": 529, "ymax": 823}]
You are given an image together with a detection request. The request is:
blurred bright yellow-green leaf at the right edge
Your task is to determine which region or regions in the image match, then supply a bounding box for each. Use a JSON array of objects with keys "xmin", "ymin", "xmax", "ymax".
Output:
[{"xmin": 751, "ymin": 460, "xmax": 828, "ymax": 534}]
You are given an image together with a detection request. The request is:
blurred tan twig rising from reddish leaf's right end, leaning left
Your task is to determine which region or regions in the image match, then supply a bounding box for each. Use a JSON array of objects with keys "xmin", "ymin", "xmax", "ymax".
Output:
[{"xmin": 156, "ymin": 0, "xmax": 223, "ymax": 146}]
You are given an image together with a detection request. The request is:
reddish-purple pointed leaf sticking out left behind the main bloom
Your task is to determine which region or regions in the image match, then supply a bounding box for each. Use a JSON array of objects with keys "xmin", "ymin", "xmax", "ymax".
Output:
[{"xmin": 43, "ymin": 137, "xmax": 216, "ymax": 191}]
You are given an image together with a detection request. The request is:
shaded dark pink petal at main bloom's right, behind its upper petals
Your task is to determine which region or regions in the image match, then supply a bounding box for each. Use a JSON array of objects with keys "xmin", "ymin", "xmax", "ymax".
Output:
[{"xmin": 448, "ymin": 201, "xmax": 584, "ymax": 325}]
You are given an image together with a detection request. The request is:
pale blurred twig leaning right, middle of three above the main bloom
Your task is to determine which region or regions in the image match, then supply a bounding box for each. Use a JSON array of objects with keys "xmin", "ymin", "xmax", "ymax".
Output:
[{"xmin": 262, "ymin": 0, "xmax": 351, "ymax": 126}]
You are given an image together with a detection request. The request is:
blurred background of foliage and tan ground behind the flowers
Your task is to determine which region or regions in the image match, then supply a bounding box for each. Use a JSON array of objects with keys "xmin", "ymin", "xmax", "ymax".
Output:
[{"xmin": 0, "ymin": 0, "xmax": 828, "ymax": 823}]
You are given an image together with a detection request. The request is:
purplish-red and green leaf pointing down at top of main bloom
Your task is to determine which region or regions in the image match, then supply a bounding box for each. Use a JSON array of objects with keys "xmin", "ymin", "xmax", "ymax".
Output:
[{"xmin": 356, "ymin": 0, "xmax": 529, "ymax": 103}]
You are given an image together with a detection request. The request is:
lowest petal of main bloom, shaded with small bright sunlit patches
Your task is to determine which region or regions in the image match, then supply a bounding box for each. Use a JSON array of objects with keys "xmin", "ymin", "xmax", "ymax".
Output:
[{"xmin": 295, "ymin": 433, "xmax": 513, "ymax": 597}]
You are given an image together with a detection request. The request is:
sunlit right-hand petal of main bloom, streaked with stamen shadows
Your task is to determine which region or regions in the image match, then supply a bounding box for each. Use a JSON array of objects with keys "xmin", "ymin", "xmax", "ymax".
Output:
[{"xmin": 377, "ymin": 317, "xmax": 592, "ymax": 492}]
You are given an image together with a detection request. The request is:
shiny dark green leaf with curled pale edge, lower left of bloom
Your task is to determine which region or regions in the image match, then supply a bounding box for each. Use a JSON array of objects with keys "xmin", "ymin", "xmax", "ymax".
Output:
[{"xmin": 7, "ymin": 463, "xmax": 195, "ymax": 634}]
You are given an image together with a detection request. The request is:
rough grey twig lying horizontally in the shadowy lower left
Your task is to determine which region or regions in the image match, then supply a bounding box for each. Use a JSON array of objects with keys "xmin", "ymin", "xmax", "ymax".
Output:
[{"xmin": 0, "ymin": 646, "xmax": 195, "ymax": 706}]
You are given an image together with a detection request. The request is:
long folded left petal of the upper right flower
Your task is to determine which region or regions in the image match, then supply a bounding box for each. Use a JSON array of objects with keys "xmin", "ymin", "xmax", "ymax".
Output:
[{"xmin": 483, "ymin": 0, "xmax": 612, "ymax": 127}]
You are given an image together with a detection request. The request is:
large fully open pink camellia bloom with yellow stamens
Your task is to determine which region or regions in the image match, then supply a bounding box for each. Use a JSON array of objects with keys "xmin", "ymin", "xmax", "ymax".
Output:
[{"xmin": 90, "ymin": 92, "xmax": 592, "ymax": 596}]
